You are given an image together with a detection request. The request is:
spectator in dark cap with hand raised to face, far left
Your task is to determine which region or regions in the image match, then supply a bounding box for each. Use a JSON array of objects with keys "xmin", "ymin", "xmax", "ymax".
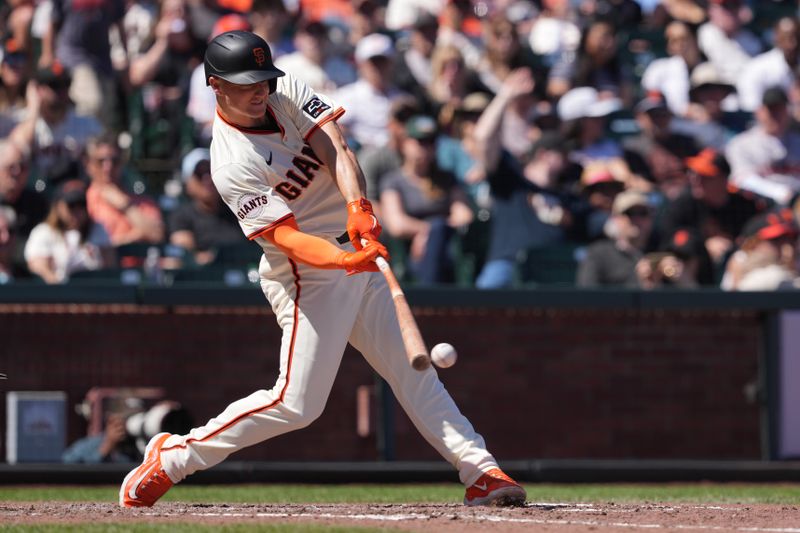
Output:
[{"xmin": 9, "ymin": 62, "xmax": 102, "ymax": 191}]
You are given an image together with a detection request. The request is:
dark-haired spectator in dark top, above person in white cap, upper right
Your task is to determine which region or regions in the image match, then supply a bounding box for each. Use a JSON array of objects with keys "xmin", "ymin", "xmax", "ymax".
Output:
[{"xmin": 547, "ymin": 20, "xmax": 633, "ymax": 102}]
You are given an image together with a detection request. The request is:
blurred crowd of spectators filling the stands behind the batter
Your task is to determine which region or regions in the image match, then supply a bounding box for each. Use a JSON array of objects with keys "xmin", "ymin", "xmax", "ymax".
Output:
[{"xmin": 0, "ymin": 0, "xmax": 800, "ymax": 290}]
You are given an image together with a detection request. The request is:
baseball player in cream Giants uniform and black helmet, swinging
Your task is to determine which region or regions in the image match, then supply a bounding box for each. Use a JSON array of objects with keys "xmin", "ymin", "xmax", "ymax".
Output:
[{"xmin": 119, "ymin": 31, "xmax": 526, "ymax": 507}]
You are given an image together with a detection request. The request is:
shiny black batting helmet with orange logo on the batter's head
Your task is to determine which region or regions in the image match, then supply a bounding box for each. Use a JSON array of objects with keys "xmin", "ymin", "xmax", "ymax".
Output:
[{"xmin": 204, "ymin": 30, "xmax": 285, "ymax": 88}]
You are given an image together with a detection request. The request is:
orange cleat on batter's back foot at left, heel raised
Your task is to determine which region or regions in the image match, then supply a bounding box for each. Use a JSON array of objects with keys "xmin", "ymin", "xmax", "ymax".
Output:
[{"xmin": 119, "ymin": 433, "xmax": 173, "ymax": 507}]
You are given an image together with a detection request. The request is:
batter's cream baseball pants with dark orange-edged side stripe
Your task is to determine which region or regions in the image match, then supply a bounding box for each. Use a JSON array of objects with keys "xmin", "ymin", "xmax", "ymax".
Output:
[{"xmin": 161, "ymin": 261, "xmax": 497, "ymax": 486}]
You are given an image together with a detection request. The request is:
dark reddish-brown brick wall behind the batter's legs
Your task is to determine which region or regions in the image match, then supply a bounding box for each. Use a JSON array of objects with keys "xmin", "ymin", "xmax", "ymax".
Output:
[{"xmin": 0, "ymin": 305, "xmax": 763, "ymax": 460}]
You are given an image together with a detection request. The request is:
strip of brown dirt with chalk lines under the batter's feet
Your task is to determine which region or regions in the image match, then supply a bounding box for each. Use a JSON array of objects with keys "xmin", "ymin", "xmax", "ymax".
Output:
[{"xmin": 0, "ymin": 502, "xmax": 800, "ymax": 533}]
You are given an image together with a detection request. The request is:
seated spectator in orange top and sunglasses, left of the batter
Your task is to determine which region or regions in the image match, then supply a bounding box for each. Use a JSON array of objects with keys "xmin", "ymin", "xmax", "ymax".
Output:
[{"xmin": 84, "ymin": 135, "xmax": 164, "ymax": 246}]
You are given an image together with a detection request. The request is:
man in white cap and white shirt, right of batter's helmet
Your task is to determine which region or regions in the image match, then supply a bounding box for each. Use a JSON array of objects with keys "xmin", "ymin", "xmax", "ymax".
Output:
[{"xmin": 335, "ymin": 33, "xmax": 402, "ymax": 148}]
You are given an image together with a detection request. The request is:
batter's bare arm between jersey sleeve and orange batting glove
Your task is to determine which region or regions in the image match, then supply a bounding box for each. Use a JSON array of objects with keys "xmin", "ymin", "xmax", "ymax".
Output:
[{"xmin": 308, "ymin": 121, "xmax": 367, "ymax": 202}]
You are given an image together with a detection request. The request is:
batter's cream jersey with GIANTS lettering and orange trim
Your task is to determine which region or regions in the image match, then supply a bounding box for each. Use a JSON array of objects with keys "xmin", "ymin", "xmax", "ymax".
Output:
[{"xmin": 211, "ymin": 74, "xmax": 347, "ymax": 266}]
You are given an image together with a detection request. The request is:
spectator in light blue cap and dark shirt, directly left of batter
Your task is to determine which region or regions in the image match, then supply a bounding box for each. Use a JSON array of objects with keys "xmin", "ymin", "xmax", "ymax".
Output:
[{"xmin": 169, "ymin": 148, "xmax": 242, "ymax": 265}]
